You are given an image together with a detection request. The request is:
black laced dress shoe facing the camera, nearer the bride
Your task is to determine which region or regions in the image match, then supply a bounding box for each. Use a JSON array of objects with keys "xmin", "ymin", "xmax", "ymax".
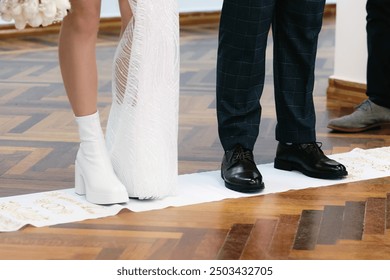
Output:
[{"xmin": 221, "ymin": 145, "xmax": 264, "ymax": 193}]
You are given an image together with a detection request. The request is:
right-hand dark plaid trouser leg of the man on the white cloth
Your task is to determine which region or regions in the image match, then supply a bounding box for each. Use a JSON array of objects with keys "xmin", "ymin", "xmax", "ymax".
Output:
[{"xmin": 273, "ymin": 0, "xmax": 325, "ymax": 143}]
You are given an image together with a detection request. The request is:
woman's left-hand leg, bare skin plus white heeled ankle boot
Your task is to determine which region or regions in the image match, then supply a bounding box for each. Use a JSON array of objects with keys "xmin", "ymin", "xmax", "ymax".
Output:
[{"xmin": 59, "ymin": 0, "xmax": 129, "ymax": 204}]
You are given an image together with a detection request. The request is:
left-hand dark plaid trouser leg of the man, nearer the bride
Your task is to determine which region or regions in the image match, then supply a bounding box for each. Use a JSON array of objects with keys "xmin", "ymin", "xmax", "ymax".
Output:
[{"xmin": 217, "ymin": 0, "xmax": 275, "ymax": 150}]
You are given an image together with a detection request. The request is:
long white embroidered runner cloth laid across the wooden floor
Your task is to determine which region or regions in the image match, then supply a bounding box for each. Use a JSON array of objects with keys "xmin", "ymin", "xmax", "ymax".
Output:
[{"xmin": 0, "ymin": 147, "xmax": 390, "ymax": 232}]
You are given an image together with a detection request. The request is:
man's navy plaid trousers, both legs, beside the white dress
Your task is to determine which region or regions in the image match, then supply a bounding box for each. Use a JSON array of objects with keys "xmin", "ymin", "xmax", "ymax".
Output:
[{"xmin": 216, "ymin": 0, "xmax": 325, "ymax": 150}]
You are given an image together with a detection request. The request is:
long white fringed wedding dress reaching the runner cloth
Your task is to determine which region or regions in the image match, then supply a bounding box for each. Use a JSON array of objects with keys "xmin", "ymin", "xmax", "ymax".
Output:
[{"xmin": 106, "ymin": 0, "xmax": 180, "ymax": 199}]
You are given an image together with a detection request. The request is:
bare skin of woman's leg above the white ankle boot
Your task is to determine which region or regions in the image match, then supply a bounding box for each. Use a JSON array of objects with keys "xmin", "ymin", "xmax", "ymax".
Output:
[{"xmin": 59, "ymin": 0, "xmax": 101, "ymax": 116}]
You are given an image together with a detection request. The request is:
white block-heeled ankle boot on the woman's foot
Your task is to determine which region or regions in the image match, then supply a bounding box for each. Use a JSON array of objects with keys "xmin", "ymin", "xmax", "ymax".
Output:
[{"xmin": 75, "ymin": 112, "xmax": 129, "ymax": 204}]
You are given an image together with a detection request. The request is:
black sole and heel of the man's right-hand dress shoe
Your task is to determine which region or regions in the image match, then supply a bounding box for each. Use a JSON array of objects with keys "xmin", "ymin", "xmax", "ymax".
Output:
[{"xmin": 274, "ymin": 158, "xmax": 348, "ymax": 179}]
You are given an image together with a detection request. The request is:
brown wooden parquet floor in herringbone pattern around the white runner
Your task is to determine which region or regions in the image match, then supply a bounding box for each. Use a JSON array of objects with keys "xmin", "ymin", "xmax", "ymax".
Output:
[{"xmin": 0, "ymin": 17, "xmax": 390, "ymax": 260}]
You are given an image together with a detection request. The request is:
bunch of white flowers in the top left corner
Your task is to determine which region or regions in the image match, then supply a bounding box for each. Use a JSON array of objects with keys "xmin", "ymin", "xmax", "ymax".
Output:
[{"xmin": 0, "ymin": 0, "xmax": 70, "ymax": 29}]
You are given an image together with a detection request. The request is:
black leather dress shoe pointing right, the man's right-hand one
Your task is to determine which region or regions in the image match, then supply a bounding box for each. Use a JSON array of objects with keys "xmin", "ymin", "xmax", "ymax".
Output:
[{"xmin": 274, "ymin": 142, "xmax": 348, "ymax": 179}]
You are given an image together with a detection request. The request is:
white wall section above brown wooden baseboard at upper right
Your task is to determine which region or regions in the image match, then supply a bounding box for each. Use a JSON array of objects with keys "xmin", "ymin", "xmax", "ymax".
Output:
[{"xmin": 332, "ymin": 0, "xmax": 367, "ymax": 84}]
